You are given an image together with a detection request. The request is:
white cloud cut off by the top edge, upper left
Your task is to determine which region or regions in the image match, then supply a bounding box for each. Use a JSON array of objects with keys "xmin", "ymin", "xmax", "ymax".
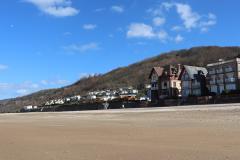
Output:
[{"xmin": 24, "ymin": 0, "xmax": 79, "ymax": 17}]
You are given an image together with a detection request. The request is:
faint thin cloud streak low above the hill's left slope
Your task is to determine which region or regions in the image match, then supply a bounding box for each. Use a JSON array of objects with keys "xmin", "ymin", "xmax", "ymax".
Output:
[{"xmin": 63, "ymin": 42, "xmax": 99, "ymax": 53}]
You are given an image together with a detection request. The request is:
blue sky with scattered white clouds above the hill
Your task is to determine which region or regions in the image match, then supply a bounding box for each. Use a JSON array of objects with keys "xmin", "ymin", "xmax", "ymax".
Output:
[{"xmin": 0, "ymin": 0, "xmax": 240, "ymax": 99}]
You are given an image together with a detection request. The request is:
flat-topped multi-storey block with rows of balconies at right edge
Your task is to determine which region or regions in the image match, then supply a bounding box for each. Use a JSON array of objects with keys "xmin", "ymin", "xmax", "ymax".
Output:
[{"xmin": 207, "ymin": 58, "xmax": 240, "ymax": 94}]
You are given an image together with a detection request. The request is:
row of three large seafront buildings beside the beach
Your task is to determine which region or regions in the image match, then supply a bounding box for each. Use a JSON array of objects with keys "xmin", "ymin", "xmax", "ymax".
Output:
[{"xmin": 149, "ymin": 58, "xmax": 240, "ymax": 102}]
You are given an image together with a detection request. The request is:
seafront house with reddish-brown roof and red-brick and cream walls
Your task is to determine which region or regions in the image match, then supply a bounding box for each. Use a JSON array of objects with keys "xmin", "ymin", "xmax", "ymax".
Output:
[{"xmin": 149, "ymin": 65, "xmax": 181, "ymax": 102}]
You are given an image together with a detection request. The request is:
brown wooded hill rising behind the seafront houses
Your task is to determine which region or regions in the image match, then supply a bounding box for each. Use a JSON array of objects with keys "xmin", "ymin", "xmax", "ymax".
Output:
[{"xmin": 0, "ymin": 46, "xmax": 240, "ymax": 112}]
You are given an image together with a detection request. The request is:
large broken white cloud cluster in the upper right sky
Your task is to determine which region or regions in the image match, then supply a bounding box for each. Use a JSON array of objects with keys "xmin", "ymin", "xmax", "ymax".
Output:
[{"xmin": 127, "ymin": 2, "xmax": 217, "ymax": 43}]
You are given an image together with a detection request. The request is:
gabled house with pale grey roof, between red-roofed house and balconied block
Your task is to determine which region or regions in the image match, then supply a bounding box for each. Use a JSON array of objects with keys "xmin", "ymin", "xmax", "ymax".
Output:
[{"xmin": 179, "ymin": 65, "xmax": 208, "ymax": 97}]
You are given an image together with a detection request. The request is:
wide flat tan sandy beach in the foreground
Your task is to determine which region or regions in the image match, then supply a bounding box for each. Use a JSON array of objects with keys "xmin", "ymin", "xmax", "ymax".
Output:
[{"xmin": 0, "ymin": 104, "xmax": 240, "ymax": 160}]
